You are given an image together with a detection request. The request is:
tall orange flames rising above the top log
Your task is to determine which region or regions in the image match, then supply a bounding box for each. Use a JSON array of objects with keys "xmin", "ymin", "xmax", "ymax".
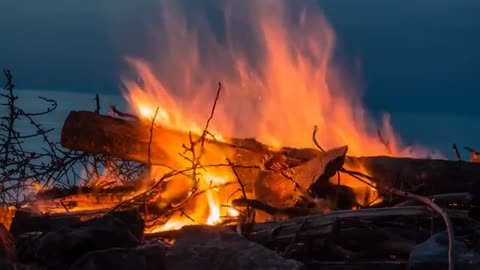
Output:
[{"xmin": 119, "ymin": 0, "xmax": 438, "ymax": 230}]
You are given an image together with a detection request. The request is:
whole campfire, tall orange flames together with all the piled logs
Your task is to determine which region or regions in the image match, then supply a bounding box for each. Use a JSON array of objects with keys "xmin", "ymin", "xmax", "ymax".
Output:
[{"xmin": 2, "ymin": 1, "xmax": 480, "ymax": 269}]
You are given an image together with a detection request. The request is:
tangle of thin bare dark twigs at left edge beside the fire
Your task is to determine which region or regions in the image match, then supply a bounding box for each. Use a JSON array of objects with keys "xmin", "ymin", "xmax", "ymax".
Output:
[{"xmin": 0, "ymin": 70, "xmax": 143, "ymax": 206}]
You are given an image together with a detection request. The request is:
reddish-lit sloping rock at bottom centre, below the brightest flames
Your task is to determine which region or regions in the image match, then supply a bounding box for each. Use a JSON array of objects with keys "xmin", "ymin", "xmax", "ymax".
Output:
[{"xmin": 166, "ymin": 226, "xmax": 304, "ymax": 270}]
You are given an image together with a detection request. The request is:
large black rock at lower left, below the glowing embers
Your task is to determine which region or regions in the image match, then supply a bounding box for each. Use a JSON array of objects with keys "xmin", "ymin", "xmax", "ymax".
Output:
[{"xmin": 17, "ymin": 214, "xmax": 143, "ymax": 270}]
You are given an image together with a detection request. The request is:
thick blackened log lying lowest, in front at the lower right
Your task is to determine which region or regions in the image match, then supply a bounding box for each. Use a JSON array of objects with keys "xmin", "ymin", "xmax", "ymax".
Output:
[{"xmin": 146, "ymin": 207, "xmax": 477, "ymax": 262}]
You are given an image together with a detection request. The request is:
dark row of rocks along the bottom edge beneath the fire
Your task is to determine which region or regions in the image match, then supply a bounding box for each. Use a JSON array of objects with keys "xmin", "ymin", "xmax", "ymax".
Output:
[{"xmin": 0, "ymin": 211, "xmax": 480, "ymax": 270}]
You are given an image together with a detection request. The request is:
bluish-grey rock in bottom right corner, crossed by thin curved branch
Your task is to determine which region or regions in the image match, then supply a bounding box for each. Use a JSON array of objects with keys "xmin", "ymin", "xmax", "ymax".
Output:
[{"xmin": 408, "ymin": 232, "xmax": 480, "ymax": 270}]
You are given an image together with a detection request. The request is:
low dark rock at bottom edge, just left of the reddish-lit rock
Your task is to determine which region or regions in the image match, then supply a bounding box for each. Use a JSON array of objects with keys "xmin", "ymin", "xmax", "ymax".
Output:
[{"xmin": 68, "ymin": 244, "xmax": 166, "ymax": 270}]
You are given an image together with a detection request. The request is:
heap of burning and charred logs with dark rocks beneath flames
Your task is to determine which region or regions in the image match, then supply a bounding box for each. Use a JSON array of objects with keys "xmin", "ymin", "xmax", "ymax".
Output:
[{"xmin": 0, "ymin": 112, "xmax": 480, "ymax": 269}]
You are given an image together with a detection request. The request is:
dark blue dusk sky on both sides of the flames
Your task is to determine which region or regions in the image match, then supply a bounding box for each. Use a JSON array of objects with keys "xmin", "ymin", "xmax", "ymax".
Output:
[{"xmin": 0, "ymin": 0, "xmax": 480, "ymax": 155}]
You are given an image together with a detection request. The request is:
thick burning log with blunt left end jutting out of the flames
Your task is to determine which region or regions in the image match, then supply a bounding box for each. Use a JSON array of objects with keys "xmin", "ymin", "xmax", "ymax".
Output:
[{"xmin": 61, "ymin": 111, "xmax": 318, "ymax": 167}]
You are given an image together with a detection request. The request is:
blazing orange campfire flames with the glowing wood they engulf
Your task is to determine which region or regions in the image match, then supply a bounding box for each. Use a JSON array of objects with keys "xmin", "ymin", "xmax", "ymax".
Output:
[{"xmin": 29, "ymin": 0, "xmax": 426, "ymax": 232}]
